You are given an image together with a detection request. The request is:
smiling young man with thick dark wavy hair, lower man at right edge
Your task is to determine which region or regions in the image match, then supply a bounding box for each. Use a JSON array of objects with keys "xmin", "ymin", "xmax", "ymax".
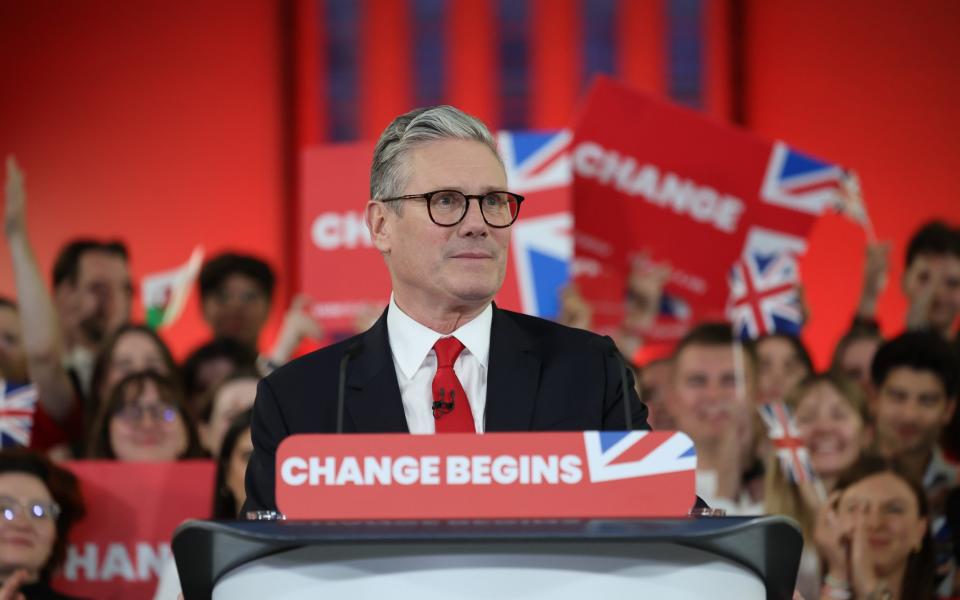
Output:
[{"xmin": 871, "ymin": 330, "xmax": 960, "ymax": 590}]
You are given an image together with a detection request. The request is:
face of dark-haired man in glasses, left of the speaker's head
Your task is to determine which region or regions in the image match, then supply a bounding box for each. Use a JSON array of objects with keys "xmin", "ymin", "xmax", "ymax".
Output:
[{"xmin": 203, "ymin": 273, "xmax": 270, "ymax": 348}]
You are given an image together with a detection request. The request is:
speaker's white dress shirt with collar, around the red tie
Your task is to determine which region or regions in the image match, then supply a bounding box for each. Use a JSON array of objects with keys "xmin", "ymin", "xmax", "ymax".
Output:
[{"xmin": 387, "ymin": 294, "xmax": 493, "ymax": 433}]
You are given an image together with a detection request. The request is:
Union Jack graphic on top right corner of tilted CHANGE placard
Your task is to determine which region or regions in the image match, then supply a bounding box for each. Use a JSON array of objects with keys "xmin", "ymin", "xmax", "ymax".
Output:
[{"xmin": 760, "ymin": 142, "xmax": 846, "ymax": 215}]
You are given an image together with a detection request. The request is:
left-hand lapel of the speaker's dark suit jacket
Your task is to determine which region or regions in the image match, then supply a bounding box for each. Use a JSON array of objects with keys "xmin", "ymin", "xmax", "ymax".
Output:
[{"xmin": 345, "ymin": 310, "xmax": 409, "ymax": 433}]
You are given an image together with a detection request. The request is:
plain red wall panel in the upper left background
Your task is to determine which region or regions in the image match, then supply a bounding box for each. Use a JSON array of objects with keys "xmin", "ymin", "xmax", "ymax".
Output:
[{"xmin": 0, "ymin": 0, "xmax": 290, "ymax": 354}]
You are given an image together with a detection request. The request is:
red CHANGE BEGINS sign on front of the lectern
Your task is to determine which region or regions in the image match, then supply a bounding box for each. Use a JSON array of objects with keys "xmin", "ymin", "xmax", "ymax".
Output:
[{"xmin": 277, "ymin": 431, "xmax": 696, "ymax": 519}]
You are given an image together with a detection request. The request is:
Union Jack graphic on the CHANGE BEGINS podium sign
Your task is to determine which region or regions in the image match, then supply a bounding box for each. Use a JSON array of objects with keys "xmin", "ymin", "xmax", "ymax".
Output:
[{"xmin": 583, "ymin": 431, "xmax": 697, "ymax": 482}]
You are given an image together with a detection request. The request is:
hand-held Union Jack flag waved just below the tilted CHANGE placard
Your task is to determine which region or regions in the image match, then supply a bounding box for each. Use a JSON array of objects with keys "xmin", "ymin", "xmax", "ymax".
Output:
[{"xmin": 727, "ymin": 251, "xmax": 803, "ymax": 339}]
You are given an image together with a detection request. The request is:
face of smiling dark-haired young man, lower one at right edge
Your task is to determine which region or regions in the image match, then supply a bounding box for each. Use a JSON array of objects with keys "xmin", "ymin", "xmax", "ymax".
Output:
[{"xmin": 873, "ymin": 367, "xmax": 956, "ymax": 456}]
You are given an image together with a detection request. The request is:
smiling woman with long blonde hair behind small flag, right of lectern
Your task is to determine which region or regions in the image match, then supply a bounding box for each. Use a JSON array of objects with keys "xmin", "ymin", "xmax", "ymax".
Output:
[{"xmin": 764, "ymin": 374, "xmax": 869, "ymax": 598}]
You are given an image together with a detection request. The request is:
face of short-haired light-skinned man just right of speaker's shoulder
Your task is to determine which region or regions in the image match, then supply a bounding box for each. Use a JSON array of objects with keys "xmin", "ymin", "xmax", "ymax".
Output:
[{"xmin": 669, "ymin": 344, "xmax": 751, "ymax": 443}]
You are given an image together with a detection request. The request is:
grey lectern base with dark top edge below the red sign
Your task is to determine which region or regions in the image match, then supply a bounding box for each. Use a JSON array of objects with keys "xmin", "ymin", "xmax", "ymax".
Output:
[{"xmin": 173, "ymin": 517, "xmax": 803, "ymax": 600}]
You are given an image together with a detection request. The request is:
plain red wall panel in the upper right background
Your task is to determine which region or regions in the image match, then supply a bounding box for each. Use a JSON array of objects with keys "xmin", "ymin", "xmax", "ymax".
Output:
[{"xmin": 744, "ymin": 0, "xmax": 960, "ymax": 359}]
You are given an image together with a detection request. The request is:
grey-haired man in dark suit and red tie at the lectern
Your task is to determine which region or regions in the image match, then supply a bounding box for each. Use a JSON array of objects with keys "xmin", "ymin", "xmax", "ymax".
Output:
[{"xmin": 244, "ymin": 106, "xmax": 648, "ymax": 511}]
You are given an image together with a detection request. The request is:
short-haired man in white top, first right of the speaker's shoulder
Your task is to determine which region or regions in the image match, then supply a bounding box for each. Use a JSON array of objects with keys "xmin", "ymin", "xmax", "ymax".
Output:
[{"xmin": 667, "ymin": 323, "xmax": 763, "ymax": 514}]
